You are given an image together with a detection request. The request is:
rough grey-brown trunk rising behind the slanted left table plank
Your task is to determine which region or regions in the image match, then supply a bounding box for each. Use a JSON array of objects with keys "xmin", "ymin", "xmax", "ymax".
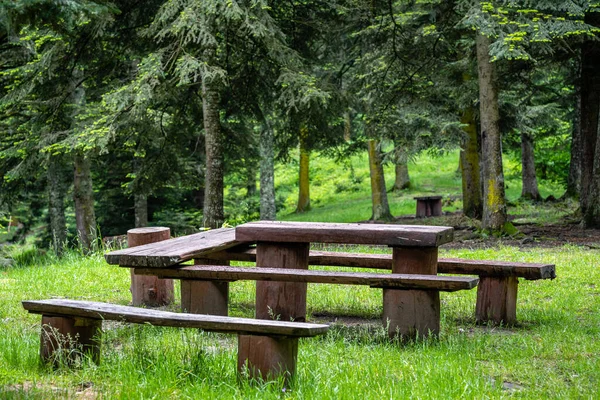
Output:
[{"xmin": 202, "ymin": 79, "xmax": 224, "ymax": 228}]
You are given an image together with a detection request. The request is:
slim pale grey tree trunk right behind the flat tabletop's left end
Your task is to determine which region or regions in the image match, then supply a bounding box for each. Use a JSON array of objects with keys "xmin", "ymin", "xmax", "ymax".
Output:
[{"xmin": 260, "ymin": 117, "xmax": 277, "ymax": 221}]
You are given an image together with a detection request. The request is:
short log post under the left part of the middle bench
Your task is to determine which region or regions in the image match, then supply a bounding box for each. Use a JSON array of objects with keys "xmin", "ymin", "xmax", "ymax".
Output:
[{"xmin": 181, "ymin": 258, "xmax": 229, "ymax": 317}]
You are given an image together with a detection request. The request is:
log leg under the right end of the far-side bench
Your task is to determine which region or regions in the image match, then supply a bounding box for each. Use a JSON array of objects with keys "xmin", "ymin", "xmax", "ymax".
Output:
[{"xmin": 475, "ymin": 276, "xmax": 519, "ymax": 325}]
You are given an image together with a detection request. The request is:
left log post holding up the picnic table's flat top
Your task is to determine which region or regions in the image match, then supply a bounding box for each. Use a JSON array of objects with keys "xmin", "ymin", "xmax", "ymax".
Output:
[{"xmin": 256, "ymin": 242, "xmax": 310, "ymax": 322}]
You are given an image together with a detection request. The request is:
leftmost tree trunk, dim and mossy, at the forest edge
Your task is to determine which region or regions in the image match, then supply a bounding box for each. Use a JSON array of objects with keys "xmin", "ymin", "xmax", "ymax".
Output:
[{"xmin": 47, "ymin": 155, "xmax": 68, "ymax": 255}]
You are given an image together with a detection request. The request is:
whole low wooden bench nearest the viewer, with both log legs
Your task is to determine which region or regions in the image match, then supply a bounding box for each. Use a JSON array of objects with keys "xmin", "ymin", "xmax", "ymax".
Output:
[{"xmin": 22, "ymin": 299, "xmax": 329, "ymax": 379}]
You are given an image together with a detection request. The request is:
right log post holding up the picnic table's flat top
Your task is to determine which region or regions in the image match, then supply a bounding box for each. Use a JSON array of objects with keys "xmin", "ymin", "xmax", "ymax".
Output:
[{"xmin": 383, "ymin": 247, "xmax": 440, "ymax": 339}]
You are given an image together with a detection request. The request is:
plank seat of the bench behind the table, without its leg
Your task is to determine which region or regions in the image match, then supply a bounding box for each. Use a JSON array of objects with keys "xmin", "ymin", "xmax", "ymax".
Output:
[{"xmin": 208, "ymin": 247, "xmax": 556, "ymax": 280}]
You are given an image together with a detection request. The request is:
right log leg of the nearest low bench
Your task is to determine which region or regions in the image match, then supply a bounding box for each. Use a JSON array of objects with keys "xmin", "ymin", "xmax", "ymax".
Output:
[{"xmin": 238, "ymin": 335, "xmax": 298, "ymax": 381}]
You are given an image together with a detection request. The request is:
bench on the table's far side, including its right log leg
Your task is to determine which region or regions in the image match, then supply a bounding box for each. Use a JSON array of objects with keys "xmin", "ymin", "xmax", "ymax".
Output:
[{"xmin": 207, "ymin": 247, "xmax": 556, "ymax": 325}]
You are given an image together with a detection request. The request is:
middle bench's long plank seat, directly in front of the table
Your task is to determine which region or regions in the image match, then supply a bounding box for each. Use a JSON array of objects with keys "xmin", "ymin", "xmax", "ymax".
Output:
[{"xmin": 136, "ymin": 265, "xmax": 478, "ymax": 292}]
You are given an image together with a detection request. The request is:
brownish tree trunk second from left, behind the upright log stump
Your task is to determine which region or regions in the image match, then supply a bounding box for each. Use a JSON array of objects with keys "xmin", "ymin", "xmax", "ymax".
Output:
[{"xmin": 73, "ymin": 153, "xmax": 98, "ymax": 254}]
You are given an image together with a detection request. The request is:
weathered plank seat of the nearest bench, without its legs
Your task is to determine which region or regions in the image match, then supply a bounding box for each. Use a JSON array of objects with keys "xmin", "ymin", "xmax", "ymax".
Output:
[{"xmin": 22, "ymin": 299, "xmax": 329, "ymax": 337}]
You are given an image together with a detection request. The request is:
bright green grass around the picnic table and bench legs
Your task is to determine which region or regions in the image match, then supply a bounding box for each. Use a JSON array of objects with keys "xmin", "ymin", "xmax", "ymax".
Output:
[{"xmin": 0, "ymin": 246, "xmax": 600, "ymax": 399}]
